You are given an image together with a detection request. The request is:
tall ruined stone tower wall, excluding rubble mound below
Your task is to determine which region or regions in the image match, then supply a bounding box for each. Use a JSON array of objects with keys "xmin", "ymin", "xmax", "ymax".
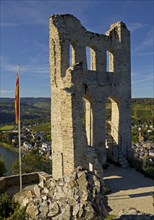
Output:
[{"xmin": 49, "ymin": 14, "xmax": 131, "ymax": 179}]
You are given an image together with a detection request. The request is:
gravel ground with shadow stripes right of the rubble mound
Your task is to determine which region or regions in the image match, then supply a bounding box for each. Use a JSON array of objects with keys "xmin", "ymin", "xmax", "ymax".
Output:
[{"xmin": 104, "ymin": 164, "xmax": 154, "ymax": 215}]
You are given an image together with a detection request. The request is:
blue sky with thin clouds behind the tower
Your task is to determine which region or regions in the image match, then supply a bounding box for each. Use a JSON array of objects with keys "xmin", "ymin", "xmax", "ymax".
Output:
[{"xmin": 0, "ymin": 0, "xmax": 154, "ymax": 97}]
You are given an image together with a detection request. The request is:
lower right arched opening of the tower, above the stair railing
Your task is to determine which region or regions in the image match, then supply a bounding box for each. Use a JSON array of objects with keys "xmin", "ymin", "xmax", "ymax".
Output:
[{"xmin": 105, "ymin": 97, "xmax": 119, "ymax": 145}]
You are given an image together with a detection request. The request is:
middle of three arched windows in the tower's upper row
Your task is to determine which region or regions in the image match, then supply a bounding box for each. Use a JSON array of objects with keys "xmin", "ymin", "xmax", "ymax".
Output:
[{"xmin": 86, "ymin": 47, "xmax": 96, "ymax": 71}]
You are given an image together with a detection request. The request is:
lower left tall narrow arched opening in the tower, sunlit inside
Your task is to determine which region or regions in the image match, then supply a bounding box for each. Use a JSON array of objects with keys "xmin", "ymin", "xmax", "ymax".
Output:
[{"xmin": 83, "ymin": 98, "xmax": 93, "ymax": 146}]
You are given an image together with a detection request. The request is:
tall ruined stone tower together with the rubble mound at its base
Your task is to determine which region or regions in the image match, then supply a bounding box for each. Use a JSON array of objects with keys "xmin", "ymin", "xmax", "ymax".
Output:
[{"xmin": 1, "ymin": 15, "xmax": 135, "ymax": 220}]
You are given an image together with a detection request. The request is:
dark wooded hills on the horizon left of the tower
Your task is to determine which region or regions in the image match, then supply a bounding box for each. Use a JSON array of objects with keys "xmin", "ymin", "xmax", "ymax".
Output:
[{"xmin": 0, "ymin": 98, "xmax": 50, "ymax": 125}]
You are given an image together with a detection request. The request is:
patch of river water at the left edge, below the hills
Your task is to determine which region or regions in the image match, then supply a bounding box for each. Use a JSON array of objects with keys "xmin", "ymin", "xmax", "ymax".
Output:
[{"xmin": 0, "ymin": 146, "xmax": 18, "ymax": 176}]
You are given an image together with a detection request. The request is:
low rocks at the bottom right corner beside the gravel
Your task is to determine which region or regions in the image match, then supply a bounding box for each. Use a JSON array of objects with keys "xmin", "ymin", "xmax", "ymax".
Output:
[{"xmin": 113, "ymin": 208, "xmax": 154, "ymax": 220}]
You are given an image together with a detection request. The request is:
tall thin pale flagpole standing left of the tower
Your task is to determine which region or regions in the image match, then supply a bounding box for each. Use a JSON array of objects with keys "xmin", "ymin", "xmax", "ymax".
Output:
[{"xmin": 17, "ymin": 64, "xmax": 22, "ymax": 191}]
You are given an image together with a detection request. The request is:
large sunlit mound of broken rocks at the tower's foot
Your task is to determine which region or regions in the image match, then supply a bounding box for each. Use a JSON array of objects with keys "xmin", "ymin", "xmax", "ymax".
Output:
[{"xmin": 15, "ymin": 167, "xmax": 108, "ymax": 220}]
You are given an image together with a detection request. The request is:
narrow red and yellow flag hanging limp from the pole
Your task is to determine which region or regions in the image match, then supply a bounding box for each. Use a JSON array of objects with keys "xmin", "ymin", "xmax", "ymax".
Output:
[{"xmin": 15, "ymin": 73, "xmax": 19, "ymax": 124}]
